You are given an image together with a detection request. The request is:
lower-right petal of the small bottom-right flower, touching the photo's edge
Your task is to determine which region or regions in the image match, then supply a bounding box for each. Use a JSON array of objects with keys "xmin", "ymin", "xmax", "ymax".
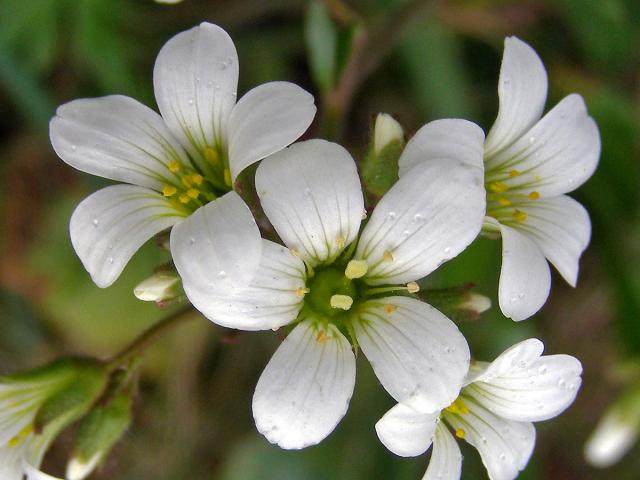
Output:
[{"xmin": 444, "ymin": 397, "xmax": 536, "ymax": 480}]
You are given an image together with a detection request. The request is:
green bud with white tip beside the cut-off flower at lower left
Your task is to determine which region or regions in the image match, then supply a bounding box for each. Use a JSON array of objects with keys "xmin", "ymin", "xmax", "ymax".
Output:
[{"xmin": 72, "ymin": 389, "xmax": 133, "ymax": 472}]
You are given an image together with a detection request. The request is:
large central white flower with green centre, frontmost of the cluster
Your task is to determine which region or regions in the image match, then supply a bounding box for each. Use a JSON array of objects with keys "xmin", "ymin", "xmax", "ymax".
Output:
[{"xmin": 171, "ymin": 121, "xmax": 485, "ymax": 449}]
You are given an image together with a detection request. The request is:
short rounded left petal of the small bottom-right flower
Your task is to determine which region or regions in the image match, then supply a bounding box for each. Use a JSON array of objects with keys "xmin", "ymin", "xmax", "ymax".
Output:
[{"xmin": 376, "ymin": 403, "xmax": 440, "ymax": 457}]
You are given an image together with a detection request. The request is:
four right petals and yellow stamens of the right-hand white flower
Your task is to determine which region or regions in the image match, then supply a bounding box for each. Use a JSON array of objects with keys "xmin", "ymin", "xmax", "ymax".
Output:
[{"xmin": 484, "ymin": 37, "xmax": 600, "ymax": 321}]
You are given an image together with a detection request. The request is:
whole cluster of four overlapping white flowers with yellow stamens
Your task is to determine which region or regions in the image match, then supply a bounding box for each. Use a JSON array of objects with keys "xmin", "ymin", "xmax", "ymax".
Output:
[{"xmin": 42, "ymin": 23, "xmax": 600, "ymax": 479}]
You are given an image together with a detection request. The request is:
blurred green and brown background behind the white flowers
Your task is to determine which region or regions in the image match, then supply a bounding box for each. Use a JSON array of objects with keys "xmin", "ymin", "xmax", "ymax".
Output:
[{"xmin": 0, "ymin": 0, "xmax": 640, "ymax": 480}]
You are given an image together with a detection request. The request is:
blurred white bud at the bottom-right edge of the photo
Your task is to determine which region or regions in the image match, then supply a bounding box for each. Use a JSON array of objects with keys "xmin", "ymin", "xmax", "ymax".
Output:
[{"xmin": 584, "ymin": 385, "xmax": 640, "ymax": 468}]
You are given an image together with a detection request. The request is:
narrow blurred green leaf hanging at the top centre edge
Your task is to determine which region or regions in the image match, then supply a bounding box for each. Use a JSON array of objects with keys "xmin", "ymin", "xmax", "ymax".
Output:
[{"xmin": 305, "ymin": 1, "xmax": 345, "ymax": 92}]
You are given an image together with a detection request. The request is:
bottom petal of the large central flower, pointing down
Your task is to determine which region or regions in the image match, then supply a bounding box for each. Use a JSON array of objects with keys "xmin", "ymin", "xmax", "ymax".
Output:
[{"xmin": 253, "ymin": 320, "xmax": 356, "ymax": 449}]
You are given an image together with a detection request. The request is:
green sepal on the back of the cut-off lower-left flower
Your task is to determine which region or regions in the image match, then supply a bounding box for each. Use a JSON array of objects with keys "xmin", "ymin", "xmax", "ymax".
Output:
[{"xmin": 33, "ymin": 359, "xmax": 108, "ymax": 432}]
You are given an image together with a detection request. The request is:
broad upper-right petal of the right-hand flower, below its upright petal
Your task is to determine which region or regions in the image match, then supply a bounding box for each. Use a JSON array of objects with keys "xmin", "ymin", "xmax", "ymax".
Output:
[{"xmin": 486, "ymin": 94, "xmax": 600, "ymax": 197}]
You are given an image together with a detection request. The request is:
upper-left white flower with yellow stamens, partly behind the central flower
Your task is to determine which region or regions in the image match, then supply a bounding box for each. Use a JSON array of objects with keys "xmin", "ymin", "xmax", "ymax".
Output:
[{"xmin": 50, "ymin": 23, "xmax": 316, "ymax": 287}]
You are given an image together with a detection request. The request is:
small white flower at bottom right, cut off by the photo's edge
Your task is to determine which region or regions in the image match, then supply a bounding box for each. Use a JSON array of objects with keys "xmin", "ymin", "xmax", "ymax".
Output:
[{"xmin": 376, "ymin": 339, "xmax": 582, "ymax": 480}]
